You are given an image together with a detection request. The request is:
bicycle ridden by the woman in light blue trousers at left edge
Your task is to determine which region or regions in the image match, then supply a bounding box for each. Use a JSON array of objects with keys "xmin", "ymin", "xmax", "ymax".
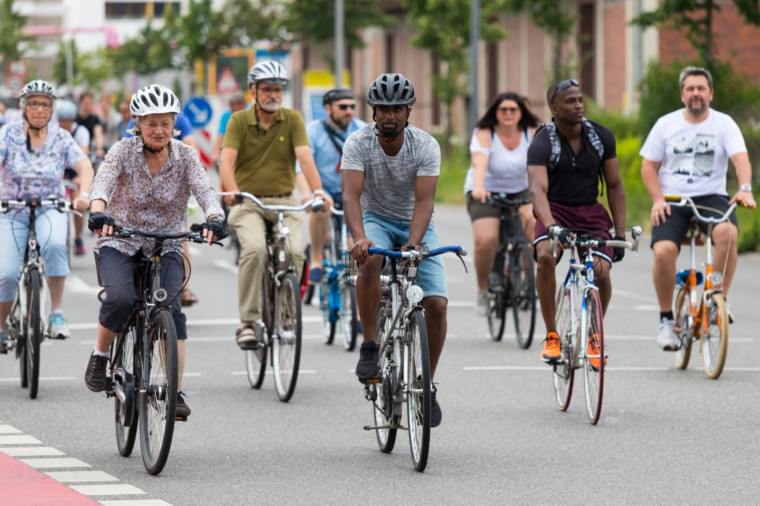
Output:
[{"xmin": 0, "ymin": 197, "xmax": 78, "ymax": 399}]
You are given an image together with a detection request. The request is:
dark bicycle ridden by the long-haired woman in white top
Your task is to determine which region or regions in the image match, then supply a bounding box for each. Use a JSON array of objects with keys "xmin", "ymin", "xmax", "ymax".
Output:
[{"xmin": 486, "ymin": 193, "xmax": 536, "ymax": 350}]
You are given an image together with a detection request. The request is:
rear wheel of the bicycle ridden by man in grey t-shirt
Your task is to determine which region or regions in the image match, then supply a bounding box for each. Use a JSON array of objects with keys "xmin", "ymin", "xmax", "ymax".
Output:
[{"xmin": 369, "ymin": 305, "xmax": 401, "ymax": 453}]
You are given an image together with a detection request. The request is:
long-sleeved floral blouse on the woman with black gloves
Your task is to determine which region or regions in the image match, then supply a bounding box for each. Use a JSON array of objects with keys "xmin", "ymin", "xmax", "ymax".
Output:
[{"xmin": 90, "ymin": 137, "xmax": 224, "ymax": 256}]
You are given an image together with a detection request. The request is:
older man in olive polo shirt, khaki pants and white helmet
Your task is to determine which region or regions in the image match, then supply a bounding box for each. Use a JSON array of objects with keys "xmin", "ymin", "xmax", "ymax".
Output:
[{"xmin": 220, "ymin": 60, "xmax": 332, "ymax": 347}]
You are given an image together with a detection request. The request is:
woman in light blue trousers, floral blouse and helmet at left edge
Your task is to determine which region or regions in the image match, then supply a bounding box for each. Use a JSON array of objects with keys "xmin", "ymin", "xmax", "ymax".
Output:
[{"xmin": 0, "ymin": 80, "xmax": 92, "ymax": 353}]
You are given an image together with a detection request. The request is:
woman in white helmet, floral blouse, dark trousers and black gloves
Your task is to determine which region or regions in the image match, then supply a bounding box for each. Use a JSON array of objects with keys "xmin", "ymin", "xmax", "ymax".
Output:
[{"xmin": 85, "ymin": 84, "xmax": 226, "ymax": 421}]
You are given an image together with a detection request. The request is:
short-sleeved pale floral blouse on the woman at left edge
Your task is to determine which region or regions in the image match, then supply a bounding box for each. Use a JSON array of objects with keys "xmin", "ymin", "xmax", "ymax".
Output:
[{"xmin": 0, "ymin": 121, "xmax": 84, "ymax": 200}]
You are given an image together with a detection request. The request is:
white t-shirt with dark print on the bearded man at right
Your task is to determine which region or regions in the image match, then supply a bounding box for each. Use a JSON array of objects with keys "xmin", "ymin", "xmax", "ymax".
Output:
[{"xmin": 639, "ymin": 109, "xmax": 747, "ymax": 197}]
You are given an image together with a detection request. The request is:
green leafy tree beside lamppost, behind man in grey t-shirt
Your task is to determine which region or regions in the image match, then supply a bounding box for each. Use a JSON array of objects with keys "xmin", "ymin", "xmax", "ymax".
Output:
[{"xmin": 406, "ymin": 0, "xmax": 505, "ymax": 152}]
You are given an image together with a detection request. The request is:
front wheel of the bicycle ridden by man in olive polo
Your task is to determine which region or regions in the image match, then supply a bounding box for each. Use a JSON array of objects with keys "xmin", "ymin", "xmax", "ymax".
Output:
[{"xmin": 272, "ymin": 272, "xmax": 301, "ymax": 402}]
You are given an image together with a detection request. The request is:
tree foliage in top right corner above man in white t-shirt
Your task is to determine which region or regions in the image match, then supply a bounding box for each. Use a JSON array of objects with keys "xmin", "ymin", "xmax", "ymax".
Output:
[{"xmin": 631, "ymin": 0, "xmax": 760, "ymax": 68}]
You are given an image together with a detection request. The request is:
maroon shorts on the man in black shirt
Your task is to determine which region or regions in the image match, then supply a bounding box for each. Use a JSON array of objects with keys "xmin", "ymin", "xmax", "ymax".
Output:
[{"xmin": 533, "ymin": 202, "xmax": 612, "ymax": 264}]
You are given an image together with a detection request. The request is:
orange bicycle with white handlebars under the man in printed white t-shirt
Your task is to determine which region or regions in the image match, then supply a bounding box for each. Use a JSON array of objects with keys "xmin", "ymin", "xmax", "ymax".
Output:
[{"xmin": 665, "ymin": 195, "xmax": 737, "ymax": 379}]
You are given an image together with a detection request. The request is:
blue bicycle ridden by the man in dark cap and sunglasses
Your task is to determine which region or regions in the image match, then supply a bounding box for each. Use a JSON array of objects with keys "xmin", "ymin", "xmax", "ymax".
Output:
[{"xmin": 319, "ymin": 207, "xmax": 359, "ymax": 351}]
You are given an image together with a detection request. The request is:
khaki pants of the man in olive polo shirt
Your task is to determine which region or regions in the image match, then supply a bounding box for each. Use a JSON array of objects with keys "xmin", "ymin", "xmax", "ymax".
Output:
[{"xmin": 228, "ymin": 196, "xmax": 304, "ymax": 322}]
